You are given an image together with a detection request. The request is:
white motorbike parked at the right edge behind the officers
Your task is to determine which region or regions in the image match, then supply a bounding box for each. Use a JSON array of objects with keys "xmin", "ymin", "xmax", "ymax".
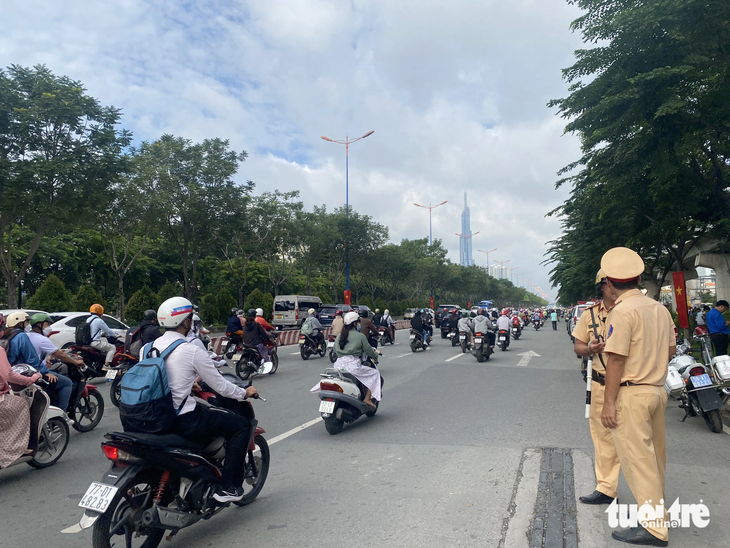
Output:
[{"xmin": 664, "ymin": 341, "xmax": 730, "ymax": 433}]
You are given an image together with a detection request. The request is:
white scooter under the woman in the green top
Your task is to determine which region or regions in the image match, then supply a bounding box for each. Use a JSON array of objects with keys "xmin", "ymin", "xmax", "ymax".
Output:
[{"xmin": 312, "ymin": 357, "xmax": 384, "ymax": 436}]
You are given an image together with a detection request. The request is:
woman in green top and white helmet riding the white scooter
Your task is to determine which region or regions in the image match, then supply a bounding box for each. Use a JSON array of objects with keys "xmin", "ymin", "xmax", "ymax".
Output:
[{"xmin": 334, "ymin": 312, "xmax": 382, "ymax": 409}]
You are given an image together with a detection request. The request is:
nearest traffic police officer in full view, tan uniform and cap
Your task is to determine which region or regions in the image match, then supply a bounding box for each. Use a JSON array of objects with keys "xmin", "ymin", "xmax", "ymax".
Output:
[{"xmin": 601, "ymin": 247, "xmax": 676, "ymax": 546}]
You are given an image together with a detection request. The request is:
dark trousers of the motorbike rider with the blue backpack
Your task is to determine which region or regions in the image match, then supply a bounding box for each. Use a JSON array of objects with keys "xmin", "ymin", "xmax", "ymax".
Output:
[{"xmin": 172, "ymin": 406, "xmax": 251, "ymax": 489}]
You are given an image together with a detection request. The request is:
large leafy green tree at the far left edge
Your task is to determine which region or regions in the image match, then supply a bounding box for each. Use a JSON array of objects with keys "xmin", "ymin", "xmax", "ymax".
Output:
[{"xmin": 0, "ymin": 65, "xmax": 130, "ymax": 307}]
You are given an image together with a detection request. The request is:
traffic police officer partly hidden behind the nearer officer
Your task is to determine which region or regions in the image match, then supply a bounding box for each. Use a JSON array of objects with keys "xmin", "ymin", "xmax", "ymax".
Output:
[{"xmin": 572, "ymin": 270, "xmax": 621, "ymax": 504}]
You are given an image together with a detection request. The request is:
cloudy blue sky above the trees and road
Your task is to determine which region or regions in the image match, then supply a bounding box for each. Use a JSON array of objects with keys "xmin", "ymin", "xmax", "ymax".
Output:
[{"xmin": 0, "ymin": 0, "xmax": 581, "ymax": 296}]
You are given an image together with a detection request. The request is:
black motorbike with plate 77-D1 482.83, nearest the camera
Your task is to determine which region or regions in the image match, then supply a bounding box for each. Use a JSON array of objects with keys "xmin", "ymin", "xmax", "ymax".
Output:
[{"xmin": 63, "ymin": 374, "xmax": 270, "ymax": 548}]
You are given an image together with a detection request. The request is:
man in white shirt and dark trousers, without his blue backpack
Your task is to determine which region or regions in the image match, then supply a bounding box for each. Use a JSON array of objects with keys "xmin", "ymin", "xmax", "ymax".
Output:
[{"xmin": 146, "ymin": 297, "xmax": 258, "ymax": 503}]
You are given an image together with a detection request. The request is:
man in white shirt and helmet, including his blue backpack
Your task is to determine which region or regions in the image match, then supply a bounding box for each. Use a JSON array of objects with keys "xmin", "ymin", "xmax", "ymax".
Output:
[{"xmin": 119, "ymin": 297, "xmax": 258, "ymax": 503}]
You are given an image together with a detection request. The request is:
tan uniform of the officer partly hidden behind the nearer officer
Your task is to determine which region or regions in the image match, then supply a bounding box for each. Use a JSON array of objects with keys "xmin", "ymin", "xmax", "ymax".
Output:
[{"xmin": 572, "ymin": 302, "xmax": 621, "ymax": 499}]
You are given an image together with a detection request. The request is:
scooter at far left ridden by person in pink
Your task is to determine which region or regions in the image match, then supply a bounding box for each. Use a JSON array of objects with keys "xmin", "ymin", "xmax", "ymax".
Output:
[{"xmin": 6, "ymin": 364, "xmax": 71, "ymax": 468}]
